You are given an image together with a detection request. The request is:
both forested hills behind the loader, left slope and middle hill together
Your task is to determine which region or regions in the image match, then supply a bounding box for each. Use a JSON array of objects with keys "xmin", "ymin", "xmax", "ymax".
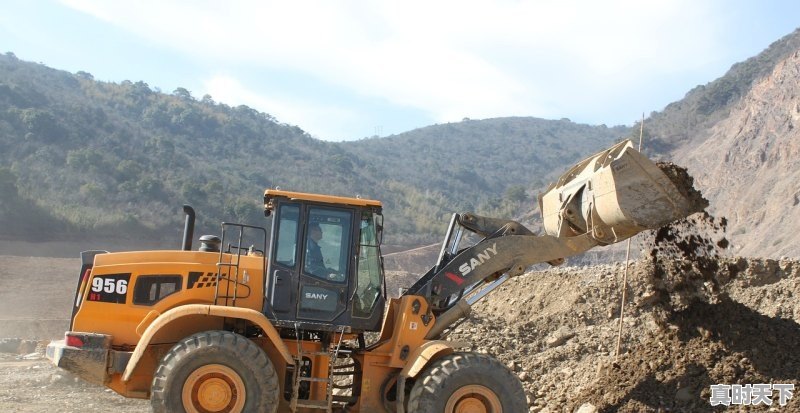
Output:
[{"xmin": 0, "ymin": 53, "xmax": 628, "ymax": 245}]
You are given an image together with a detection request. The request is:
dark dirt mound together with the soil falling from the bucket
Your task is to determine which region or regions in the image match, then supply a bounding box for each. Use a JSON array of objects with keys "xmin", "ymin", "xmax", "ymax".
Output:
[{"xmin": 557, "ymin": 164, "xmax": 800, "ymax": 412}]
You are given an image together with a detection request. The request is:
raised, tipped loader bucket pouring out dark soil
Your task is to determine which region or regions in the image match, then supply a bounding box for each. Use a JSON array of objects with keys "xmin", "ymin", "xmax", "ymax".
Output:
[{"xmin": 539, "ymin": 140, "xmax": 705, "ymax": 244}]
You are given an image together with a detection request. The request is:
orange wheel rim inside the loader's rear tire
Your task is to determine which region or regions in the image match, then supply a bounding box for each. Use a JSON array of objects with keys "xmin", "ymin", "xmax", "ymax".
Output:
[{"xmin": 181, "ymin": 364, "xmax": 246, "ymax": 413}]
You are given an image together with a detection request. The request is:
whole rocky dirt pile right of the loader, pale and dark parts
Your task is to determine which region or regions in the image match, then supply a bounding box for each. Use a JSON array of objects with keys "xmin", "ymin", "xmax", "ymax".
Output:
[{"xmin": 448, "ymin": 258, "xmax": 800, "ymax": 413}]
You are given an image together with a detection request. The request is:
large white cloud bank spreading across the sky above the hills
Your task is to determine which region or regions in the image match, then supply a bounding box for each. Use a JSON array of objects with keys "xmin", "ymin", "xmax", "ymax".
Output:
[{"xmin": 59, "ymin": 0, "xmax": 720, "ymax": 127}]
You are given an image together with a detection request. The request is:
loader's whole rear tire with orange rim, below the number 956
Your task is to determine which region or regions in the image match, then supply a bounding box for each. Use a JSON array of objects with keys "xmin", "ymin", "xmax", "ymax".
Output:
[{"xmin": 150, "ymin": 331, "xmax": 279, "ymax": 413}]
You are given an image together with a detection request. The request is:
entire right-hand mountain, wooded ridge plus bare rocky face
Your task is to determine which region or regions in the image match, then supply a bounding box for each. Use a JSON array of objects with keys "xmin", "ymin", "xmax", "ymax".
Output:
[{"xmin": 645, "ymin": 30, "xmax": 800, "ymax": 258}]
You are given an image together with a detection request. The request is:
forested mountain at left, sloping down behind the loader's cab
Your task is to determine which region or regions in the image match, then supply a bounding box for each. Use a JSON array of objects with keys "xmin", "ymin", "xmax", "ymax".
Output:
[{"xmin": 0, "ymin": 54, "xmax": 341, "ymax": 243}]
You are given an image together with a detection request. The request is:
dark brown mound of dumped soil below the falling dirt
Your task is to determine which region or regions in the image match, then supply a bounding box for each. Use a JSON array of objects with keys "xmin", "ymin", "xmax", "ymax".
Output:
[{"xmin": 576, "ymin": 299, "xmax": 800, "ymax": 412}]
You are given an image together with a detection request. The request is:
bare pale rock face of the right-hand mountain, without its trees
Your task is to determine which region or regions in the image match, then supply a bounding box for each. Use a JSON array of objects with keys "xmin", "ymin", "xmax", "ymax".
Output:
[{"xmin": 675, "ymin": 50, "xmax": 800, "ymax": 257}]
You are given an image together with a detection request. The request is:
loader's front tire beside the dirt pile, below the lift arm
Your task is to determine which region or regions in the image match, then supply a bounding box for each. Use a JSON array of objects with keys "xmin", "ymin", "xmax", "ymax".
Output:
[{"xmin": 408, "ymin": 353, "xmax": 528, "ymax": 413}]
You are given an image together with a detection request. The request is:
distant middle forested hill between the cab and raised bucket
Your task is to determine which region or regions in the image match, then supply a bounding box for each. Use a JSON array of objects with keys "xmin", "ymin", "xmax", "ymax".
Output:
[{"xmin": 341, "ymin": 117, "xmax": 628, "ymax": 245}]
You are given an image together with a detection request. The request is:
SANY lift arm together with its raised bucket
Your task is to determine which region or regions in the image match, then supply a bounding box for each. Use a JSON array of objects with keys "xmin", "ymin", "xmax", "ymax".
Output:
[{"xmin": 406, "ymin": 141, "xmax": 705, "ymax": 339}]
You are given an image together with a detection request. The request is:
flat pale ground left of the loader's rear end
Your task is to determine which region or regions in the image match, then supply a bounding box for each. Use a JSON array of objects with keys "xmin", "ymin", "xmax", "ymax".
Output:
[{"xmin": 0, "ymin": 256, "xmax": 150, "ymax": 413}]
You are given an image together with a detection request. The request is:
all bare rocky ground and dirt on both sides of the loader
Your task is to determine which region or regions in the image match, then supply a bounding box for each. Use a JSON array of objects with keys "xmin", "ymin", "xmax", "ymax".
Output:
[{"xmin": 0, "ymin": 233, "xmax": 800, "ymax": 413}]
